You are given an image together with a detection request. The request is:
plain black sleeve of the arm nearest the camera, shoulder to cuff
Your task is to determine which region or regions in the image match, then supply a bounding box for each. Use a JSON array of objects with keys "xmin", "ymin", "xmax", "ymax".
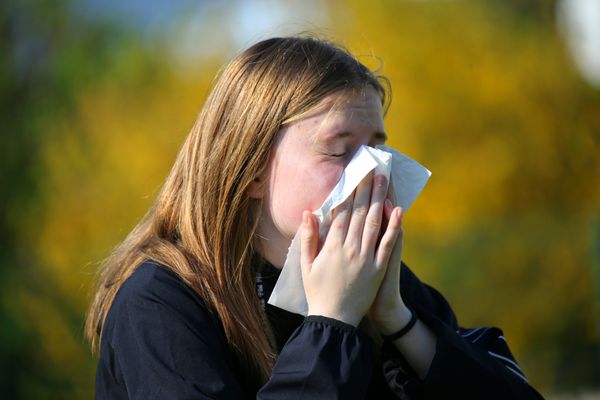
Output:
[{"xmin": 96, "ymin": 264, "xmax": 372, "ymax": 400}]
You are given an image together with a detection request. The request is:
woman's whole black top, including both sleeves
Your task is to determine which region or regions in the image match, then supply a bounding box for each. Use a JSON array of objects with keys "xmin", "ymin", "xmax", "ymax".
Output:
[{"xmin": 96, "ymin": 262, "xmax": 542, "ymax": 400}]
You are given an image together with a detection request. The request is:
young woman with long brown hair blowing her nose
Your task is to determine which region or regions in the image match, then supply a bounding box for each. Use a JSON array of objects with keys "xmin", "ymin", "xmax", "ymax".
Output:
[{"xmin": 86, "ymin": 37, "xmax": 541, "ymax": 399}]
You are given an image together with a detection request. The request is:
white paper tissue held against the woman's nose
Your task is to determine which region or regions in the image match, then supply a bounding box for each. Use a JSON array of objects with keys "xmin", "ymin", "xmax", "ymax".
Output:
[{"xmin": 269, "ymin": 146, "xmax": 431, "ymax": 315}]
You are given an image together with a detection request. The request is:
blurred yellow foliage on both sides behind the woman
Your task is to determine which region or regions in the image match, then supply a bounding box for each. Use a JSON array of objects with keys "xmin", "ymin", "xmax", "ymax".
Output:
[{"xmin": 19, "ymin": 0, "xmax": 600, "ymax": 394}]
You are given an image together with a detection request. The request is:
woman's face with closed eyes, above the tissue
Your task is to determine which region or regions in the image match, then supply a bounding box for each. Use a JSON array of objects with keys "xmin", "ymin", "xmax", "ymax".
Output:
[{"xmin": 255, "ymin": 89, "xmax": 387, "ymax": 267}]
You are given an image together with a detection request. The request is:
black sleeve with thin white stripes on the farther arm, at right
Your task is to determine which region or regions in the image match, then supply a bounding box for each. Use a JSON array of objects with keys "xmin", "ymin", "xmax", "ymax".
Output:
[{"xmin": 383, "ymin": 264, "xmax": 543, "ymax": 400}]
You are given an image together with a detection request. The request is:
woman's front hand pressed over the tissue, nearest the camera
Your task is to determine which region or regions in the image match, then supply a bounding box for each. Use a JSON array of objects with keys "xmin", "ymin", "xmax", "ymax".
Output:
[{"xmin": 301, "ymin": 172, "xmax": 401, "ymax": 326}]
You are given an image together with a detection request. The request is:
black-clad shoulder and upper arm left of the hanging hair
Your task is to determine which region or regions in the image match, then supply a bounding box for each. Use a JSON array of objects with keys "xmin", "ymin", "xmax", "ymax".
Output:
[{"xmin": 96, "ymin": 262, "xmax": 244, "ymax": 399}]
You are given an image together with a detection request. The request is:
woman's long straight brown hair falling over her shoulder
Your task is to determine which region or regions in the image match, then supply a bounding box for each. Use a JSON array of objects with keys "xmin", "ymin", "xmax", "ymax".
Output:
[{"xmin": 85, "ymin": 37, "xmax": 389, "ymax": 384}]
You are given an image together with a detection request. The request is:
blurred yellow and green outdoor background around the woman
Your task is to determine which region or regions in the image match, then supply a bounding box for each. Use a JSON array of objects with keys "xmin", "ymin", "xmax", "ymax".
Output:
[{"xmin": 0, "ymin": 0, "xmax": 600, "ymax": 399}]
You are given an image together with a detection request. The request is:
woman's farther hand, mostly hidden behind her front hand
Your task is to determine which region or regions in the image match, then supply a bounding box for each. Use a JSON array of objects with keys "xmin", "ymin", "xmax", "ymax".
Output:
[{"xmin": 368, "ymin": 199, "xmax": 411, "ymax": 335}]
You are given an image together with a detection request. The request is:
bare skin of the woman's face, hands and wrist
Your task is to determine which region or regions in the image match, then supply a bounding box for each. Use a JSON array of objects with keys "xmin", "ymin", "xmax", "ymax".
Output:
[{"xmin": 249, "ymin": 89, "xmax": 436, "ymax": 378}]
